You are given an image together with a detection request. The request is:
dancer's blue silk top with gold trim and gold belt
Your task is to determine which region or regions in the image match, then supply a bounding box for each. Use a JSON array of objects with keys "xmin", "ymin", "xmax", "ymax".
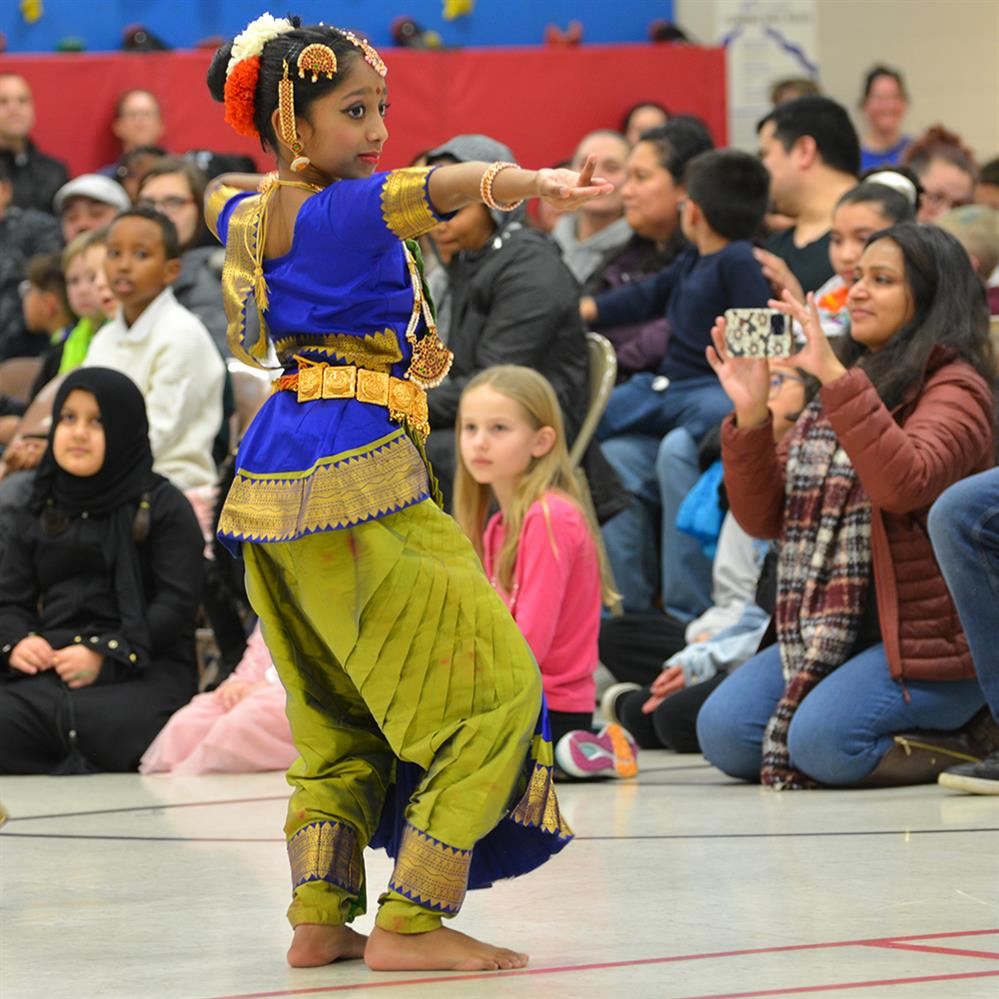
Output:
[{"xmin": 206, "ymin": 168, "xmax": 458, "ymax": 549}]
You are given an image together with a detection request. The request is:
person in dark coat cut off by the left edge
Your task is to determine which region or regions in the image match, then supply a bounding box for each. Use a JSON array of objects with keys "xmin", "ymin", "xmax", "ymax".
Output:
[{"xmin": 0, "ymin": 156, "xmax": 62, "ymax": 361}]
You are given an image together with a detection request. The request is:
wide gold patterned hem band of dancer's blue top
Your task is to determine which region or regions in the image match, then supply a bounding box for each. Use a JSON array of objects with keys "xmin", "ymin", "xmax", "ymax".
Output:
[{"xmin": 219, "ymin": 430, "xmax": 430, "ymax": 541}]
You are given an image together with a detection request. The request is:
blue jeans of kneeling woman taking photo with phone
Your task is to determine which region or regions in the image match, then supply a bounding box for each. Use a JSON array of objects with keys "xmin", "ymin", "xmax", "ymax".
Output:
[{"xmin": 697, "ymin": 643, "xmax": 983, "ymax": 787}]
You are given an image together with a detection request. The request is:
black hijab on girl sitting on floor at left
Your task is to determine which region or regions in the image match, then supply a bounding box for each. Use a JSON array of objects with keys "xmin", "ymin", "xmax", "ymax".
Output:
[{"xmin": 31, "ymin": 368, "xmax": 164, "ymax": 666}]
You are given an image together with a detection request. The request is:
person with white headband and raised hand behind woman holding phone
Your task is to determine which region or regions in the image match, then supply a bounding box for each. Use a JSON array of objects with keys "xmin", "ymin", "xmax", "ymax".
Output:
[{"xmin": 754, "ymin": 169, "xmax": 919, "ymax": 337}]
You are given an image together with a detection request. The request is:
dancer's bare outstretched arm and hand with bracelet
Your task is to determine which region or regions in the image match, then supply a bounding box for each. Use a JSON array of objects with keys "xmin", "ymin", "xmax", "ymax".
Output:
[{"xmin": 428, "ymin": 156, "xmax": 614, "ymax": 215}]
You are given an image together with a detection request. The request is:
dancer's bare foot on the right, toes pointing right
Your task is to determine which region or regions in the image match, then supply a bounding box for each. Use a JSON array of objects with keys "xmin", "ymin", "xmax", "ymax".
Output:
[{"xmin": 364, "ymin": 926, "xmax": 527, "ymax": 971}]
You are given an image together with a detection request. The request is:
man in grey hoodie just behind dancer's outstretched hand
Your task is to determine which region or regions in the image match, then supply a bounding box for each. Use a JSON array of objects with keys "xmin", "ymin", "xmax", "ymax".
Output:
[{"xmin": 552, "ymin": 130, "xmax": 631, "ymax": 284}]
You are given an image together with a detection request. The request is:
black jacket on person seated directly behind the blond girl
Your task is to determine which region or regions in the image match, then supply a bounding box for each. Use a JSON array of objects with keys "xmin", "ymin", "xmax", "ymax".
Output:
[{"xmin": 429, "ymin": 222, "xmax": 588, "ymax": 438}]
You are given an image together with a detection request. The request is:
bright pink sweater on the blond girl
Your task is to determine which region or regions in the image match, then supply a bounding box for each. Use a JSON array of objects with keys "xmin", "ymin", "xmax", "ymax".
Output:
[{"xmin": 483, "ymin": 492, "xmax": 600, "ymax": 714}]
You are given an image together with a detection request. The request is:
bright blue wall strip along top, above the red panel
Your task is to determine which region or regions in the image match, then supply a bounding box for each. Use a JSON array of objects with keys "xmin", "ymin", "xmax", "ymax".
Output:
[{"xmin": 0, "ymin": 0, "xmax": 673, "ymax": 59}]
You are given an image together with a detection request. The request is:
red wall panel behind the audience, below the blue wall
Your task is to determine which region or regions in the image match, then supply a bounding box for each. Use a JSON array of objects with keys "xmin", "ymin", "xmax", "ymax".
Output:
[{"xmin": 0, "ymin": 45, "xmax": 727, "ymax": 175}]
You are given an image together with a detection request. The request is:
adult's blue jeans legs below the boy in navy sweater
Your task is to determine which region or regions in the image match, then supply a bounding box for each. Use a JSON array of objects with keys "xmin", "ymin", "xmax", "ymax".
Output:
[{"xmin": 602, "ymin": 427, "xmax": 711, "ymax": 621}]
